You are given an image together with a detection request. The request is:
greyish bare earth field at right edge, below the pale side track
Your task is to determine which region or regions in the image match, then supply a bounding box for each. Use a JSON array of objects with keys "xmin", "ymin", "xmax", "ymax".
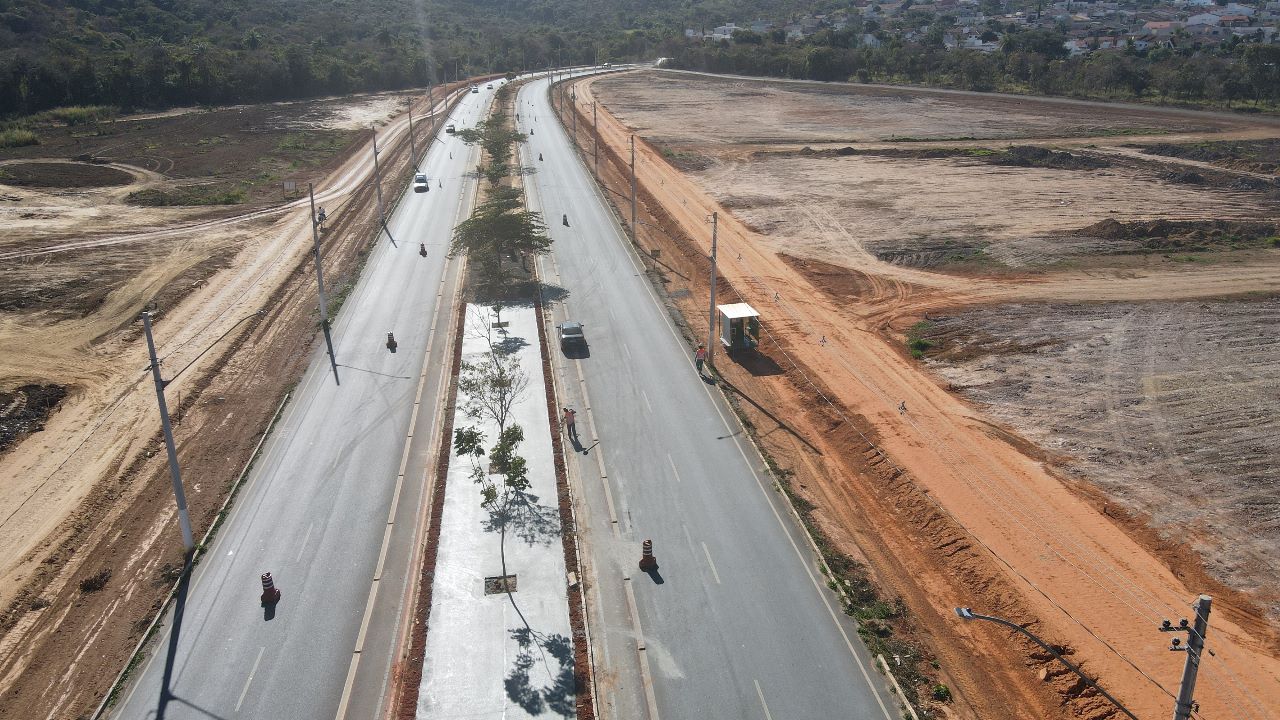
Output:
[{"xmin": 920, "ymin": 299, "xmax": 1280, "ymax": 609}]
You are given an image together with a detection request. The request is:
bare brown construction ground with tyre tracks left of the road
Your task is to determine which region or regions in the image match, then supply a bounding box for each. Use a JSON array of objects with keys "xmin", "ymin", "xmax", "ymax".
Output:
[{"xmin": 0, "ymin": 83, "xmax": 476, "ymax": 720}]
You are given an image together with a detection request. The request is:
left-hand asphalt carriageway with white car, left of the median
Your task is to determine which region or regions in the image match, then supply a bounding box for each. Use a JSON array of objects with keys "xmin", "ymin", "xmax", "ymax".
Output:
[{"xmin": 111, "ymin": 81, "xmax": 493, "ymax": 720}]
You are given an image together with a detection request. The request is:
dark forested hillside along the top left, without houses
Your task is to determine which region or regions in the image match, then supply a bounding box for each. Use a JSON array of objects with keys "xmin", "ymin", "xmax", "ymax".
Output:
[{"xmin": 0, "ymin": 0, "xmax": 844, "ymax": 117}]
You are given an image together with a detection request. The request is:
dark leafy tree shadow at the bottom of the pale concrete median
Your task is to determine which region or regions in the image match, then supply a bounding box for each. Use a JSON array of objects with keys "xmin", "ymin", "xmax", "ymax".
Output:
[{"xmin": 503, "ymin": 625, "xmax": 577, "ymax": 717}]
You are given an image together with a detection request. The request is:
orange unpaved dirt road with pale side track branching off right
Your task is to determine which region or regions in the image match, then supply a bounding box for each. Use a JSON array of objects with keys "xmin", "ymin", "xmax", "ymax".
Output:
[{"xmin": 577, "ymin": 73, "xmax": 1280, "ymax": 717}]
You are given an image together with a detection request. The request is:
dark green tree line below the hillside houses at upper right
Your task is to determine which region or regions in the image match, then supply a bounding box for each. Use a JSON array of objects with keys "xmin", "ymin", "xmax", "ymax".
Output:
[{"xmin": 673, "ymin": 29, "xmax": 1280, "ymax": 109}]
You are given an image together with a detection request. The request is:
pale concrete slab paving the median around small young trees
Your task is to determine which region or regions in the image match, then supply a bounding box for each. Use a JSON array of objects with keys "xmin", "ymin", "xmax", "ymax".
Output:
[{"xmin": 416, "ymin": 305, "xmax": 575, "ymax": 720}]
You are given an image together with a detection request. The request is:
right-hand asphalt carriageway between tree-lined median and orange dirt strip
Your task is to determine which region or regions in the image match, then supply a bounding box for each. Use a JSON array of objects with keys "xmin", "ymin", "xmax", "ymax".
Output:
[{"xmin": 520, "ymin": 74, "xmax": 899, "ymax": 720}]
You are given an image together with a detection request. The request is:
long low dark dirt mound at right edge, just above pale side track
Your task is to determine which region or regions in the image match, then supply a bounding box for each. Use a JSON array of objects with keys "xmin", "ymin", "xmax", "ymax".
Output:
[{"xmin": 1076, "ymin": 218, "xmax": 1280, "ymax": 252}]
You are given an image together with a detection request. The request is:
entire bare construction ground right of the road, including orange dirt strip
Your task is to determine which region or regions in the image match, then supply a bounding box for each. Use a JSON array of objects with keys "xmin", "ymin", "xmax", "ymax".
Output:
[{"xmin": 566, "ymin": 70, "xmax": 1280, "ymax": 719}]
